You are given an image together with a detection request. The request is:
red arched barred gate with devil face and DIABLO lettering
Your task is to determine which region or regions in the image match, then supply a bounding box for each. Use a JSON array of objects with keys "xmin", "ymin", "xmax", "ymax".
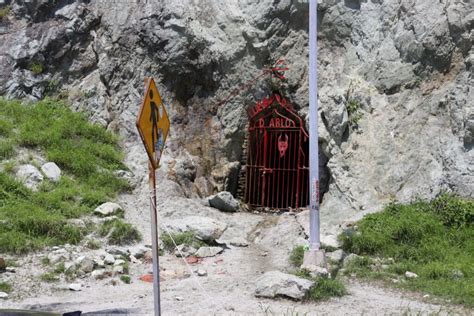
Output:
[{"xmin": 245, "ymin": 94, "xmax": 309, "ymax": 209}]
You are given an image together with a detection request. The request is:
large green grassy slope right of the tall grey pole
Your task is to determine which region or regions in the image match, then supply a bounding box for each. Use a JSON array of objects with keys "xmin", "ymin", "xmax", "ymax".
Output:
[{"xmin": 341, "ymin": 194, "xmax": 474, "ymax": 307}]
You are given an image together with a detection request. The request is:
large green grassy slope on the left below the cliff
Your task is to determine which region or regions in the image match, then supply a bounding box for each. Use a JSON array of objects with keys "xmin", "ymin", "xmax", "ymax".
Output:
[{"xmin": 0, "ymin": 98, "xmax": 130, "ymax": 253}]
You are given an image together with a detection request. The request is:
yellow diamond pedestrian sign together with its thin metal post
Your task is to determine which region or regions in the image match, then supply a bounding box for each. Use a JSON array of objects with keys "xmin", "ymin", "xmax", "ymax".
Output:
[{"xmin": 137, "ymin": 78, "xmax": 170, "ymax": 316}]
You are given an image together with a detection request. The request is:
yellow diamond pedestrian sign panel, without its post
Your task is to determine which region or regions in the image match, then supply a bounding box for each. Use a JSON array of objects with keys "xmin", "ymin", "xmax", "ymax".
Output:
[{"xmin": 137, "ymin": 78, "xmax": 170, "ymax": 169}]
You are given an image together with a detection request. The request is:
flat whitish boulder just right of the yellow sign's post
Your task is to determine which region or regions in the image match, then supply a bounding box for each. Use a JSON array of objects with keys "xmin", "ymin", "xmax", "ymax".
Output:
[{"xmin": 162, "ymin": 216, "xmax": 227, "ymax": 241}]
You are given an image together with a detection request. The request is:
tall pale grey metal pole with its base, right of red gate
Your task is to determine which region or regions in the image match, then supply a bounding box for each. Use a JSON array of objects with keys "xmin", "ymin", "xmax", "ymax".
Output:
[{"xmin": 303, "ymin": 0, "xmax": 326, "ymax": 266}]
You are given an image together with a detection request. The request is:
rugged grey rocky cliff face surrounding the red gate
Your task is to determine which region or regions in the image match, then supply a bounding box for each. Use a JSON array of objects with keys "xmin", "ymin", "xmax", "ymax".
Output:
[{"xmin": 0, "ymin": 0, "xmax": 474, "ymax": 230}]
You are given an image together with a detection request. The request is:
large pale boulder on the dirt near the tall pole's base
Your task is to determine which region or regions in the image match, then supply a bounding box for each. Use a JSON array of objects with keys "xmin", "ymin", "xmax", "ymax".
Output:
[{"xmin": 255, "ymin": 271, "xmax": 315, "ymax": 300}]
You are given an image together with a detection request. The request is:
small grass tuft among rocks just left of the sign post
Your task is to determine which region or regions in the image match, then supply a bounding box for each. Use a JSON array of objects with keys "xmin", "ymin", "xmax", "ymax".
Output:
[{"xmin": 99, "ymin": 219, "xmax": 142, "ymax": 245}]
